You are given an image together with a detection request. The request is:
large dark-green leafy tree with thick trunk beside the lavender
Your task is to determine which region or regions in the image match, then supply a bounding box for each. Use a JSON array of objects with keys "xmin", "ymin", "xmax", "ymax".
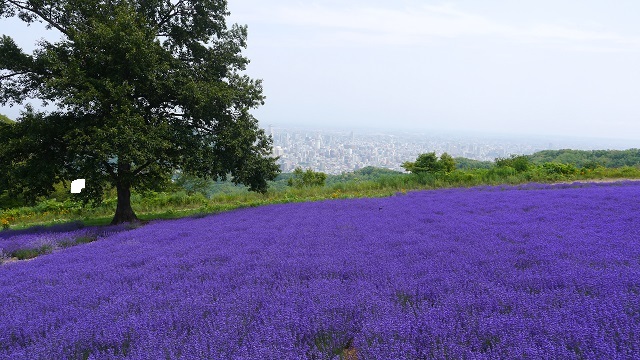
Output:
[{"xmin": 0, "ymin": 0, "xmax": 278, "ymax": 223}]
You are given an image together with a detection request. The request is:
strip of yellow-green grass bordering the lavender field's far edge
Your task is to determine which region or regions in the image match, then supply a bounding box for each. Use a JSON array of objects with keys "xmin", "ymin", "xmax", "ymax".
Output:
[{"xmin": 0, "ymin": 166, "xmax": 640, "ymax": 229}]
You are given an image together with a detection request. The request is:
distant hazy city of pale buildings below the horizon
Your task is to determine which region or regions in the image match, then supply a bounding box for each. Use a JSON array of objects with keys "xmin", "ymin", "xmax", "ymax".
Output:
[{"xmin": 265, "ymin": 125, "xmax": 629, "ymax": 175}]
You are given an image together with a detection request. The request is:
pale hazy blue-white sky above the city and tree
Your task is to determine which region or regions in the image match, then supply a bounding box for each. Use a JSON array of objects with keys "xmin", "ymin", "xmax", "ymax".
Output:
[{"xmin": 0, "ymin": 0, "xmax": 640, "ymax": 139}]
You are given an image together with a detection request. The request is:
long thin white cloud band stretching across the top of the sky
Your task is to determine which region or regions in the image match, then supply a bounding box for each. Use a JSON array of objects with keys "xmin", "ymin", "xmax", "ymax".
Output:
[{"xmin": 236, "ymin": 2, "xmax": 640, "ymax": 51}]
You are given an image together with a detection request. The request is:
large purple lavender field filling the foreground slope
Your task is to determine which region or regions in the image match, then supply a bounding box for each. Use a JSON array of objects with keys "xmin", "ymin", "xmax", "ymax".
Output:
[{"xmin": 0, "ymin": 182, "xmax": 640, "ymax": 359}]
